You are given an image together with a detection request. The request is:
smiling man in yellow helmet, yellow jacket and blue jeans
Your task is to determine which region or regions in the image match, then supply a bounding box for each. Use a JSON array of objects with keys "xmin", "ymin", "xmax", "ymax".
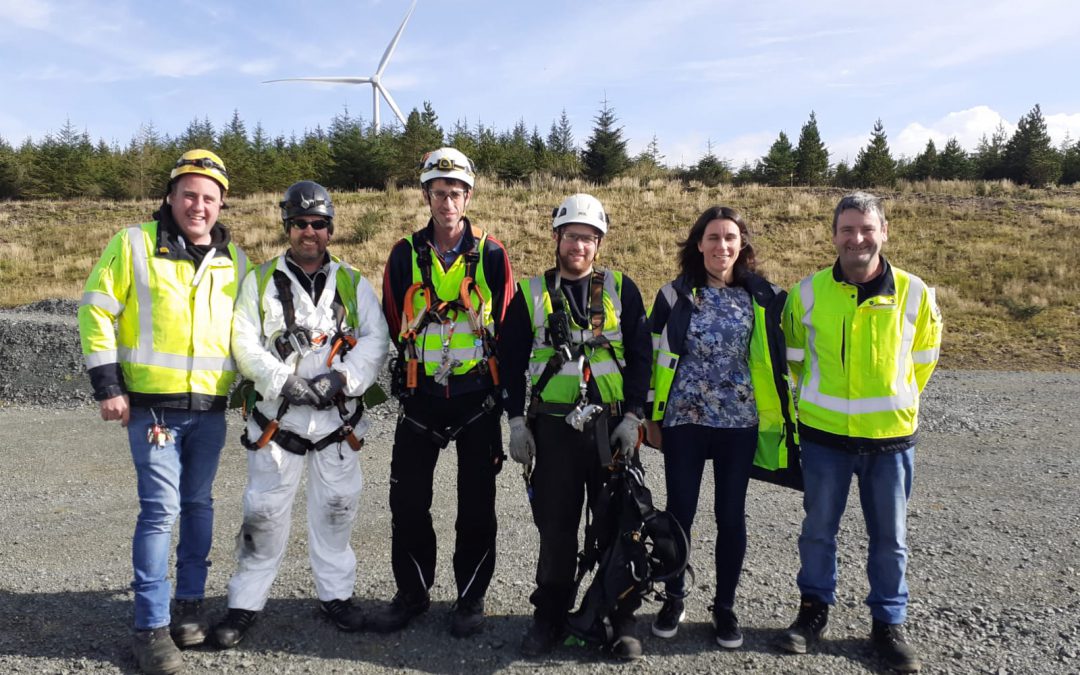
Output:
[{"xmin": 79, "ymin": 149, "xmax": 249, "ymax": 673}]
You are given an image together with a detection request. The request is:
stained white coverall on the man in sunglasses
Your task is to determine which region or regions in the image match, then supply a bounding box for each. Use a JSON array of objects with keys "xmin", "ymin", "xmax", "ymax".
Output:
[{"xmin": 229, "ymin": 256, "xmax": 390, "ymax": 611}]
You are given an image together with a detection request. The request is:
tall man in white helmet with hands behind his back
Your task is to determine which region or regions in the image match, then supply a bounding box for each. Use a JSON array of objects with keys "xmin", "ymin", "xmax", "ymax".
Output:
[{"xmin": 369, "ymin": 148, "xmax": 513, "ymax": 637}]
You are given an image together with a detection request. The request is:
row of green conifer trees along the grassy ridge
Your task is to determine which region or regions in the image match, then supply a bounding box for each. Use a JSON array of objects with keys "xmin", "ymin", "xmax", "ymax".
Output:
[{"xmin": 0, "ymin": 102, "xmax": 1080, "ymax": 200}]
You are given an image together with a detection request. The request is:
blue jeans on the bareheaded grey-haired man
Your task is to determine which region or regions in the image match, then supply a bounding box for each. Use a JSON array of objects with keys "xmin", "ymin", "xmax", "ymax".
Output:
[{"xmin": 797, "ymin": 441, "xmax": 915, "ymax": 623}]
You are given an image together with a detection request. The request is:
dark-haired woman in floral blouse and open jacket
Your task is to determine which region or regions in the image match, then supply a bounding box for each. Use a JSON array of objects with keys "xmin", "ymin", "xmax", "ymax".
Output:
[{"xmin": 648, "ymin": 206, "xmax": 798, "ymax": 649}]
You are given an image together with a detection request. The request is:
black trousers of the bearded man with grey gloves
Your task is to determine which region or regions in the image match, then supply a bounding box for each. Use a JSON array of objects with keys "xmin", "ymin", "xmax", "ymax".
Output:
[{"xmin": 529, "ymin": 415, "xmax": 642, "ymax": 623}]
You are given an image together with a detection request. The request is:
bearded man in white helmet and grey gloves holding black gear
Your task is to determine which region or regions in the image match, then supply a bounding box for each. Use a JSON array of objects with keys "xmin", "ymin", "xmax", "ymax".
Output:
[{"xmin": 499, "ymin": 194, "xmax": 651, "ymax": 659}]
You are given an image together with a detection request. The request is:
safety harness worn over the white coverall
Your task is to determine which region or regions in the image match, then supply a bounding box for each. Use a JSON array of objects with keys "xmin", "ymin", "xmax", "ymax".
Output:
[{"xmin": 240, "ymin": 260, "xmax": 364, "ymax": 455}]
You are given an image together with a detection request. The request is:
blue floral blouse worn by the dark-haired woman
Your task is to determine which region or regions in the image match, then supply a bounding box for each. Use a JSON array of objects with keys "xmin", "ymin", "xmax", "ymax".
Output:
[{"xmin": 663, "ymin": 286, "xmax": 757, "ymax": 429}]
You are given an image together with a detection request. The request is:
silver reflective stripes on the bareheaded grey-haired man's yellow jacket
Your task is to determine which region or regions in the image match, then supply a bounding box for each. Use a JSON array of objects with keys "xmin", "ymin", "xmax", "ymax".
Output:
[{"xmin": 799, "ymin": 272, "xmax": 924, "ymax": 415}]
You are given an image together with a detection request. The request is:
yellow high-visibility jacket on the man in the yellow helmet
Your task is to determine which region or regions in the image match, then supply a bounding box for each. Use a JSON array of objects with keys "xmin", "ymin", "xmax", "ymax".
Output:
[{"xmin": 79, "ymin": 221, "xmax": 249, "ymax": 409}]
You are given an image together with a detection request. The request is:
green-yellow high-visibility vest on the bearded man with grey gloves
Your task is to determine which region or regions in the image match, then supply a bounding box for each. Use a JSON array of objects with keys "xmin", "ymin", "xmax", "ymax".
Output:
[{"xmin": 521, "ymin": 270, "xmax": 626, "ymax": 403}]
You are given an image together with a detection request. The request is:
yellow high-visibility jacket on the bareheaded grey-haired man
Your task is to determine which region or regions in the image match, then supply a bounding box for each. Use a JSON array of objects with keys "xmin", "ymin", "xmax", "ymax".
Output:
[{"xmin": 784, "ymin": 260, "xmax": 942, "ymax": 440}]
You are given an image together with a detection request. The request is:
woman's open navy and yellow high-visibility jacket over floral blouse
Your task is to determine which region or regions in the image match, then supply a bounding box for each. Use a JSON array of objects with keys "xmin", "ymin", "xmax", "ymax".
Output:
[{"xmin": 649, "ymin": 274, "xmax": 798, "ymax": 473}]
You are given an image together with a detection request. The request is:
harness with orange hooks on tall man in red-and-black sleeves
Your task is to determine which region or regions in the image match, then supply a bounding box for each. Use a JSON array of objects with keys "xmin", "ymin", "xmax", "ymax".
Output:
[{"xmin": 392, "ymin": 232, "xmax": 499, "ymax": 399}]
